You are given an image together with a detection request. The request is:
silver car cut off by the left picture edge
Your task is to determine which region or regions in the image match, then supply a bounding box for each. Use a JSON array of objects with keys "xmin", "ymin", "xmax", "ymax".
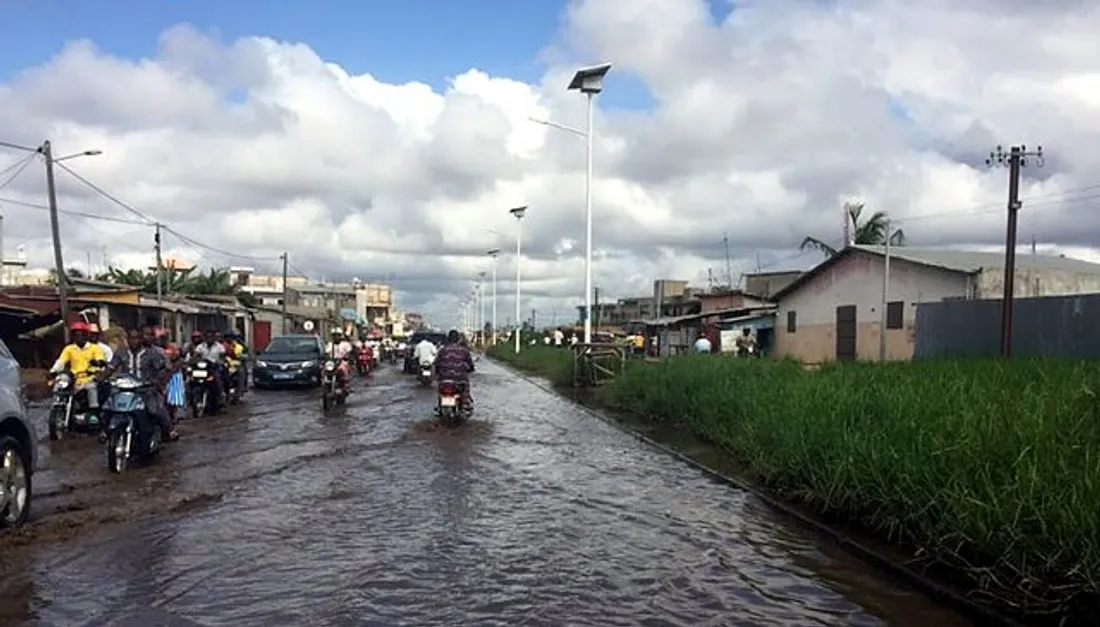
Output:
[{"xmin": 0, "ymin": 334, "xmax": 39, "ymax": 527}]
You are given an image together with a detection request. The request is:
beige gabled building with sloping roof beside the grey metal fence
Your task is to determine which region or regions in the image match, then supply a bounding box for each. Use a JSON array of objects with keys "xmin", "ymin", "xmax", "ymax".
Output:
[{"xmin": 774, "ymin": 246, "xmax": 1100, "ymax": 363}]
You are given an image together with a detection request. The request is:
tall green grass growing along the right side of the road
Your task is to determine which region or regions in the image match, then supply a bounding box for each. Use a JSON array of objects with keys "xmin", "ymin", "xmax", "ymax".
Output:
[{"xmin": 495, "ymin": 349, "xmax": 1100, "ymax": 615}]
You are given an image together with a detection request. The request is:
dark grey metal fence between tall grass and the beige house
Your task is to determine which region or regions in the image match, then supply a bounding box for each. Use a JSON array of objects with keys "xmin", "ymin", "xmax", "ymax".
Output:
[{"xmin": 913, "ymin": 294, "xmax": 1100, "ymax": 359}]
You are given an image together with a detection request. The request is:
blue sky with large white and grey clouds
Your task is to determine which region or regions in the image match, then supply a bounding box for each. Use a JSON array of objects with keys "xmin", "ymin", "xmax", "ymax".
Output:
[{"xmin": 0, "ymin": 0, "xmax": 1100, "ymax": 326}]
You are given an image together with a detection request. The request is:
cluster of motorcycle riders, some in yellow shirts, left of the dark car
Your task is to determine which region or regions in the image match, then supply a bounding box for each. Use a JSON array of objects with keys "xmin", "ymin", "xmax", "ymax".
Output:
[{"xmin": 50, "ymin": 322, "xmax": 248, "ymax": 440}]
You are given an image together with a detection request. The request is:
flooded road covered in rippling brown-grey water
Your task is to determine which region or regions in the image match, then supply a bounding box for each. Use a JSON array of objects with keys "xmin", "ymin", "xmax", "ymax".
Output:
[{"xmin": 0, "ymin": 360, "xmax": 971, "ymax": 627}]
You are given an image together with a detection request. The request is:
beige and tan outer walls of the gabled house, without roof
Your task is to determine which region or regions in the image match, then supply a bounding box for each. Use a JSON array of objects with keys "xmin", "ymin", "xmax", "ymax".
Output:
[{"xmin": 776, "ymin": 253, "xmax": 972, "ymax": 363}]
